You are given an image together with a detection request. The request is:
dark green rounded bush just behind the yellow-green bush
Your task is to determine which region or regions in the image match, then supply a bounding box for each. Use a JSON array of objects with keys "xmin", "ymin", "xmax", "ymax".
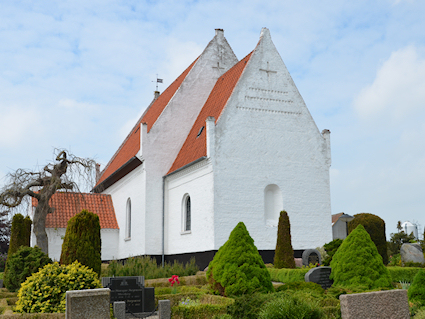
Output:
[{"xmin": 4, "ymin": 246, "xmax": 52, "ymax": 291}]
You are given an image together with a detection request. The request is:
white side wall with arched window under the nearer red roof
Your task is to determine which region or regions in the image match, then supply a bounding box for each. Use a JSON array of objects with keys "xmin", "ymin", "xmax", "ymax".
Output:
[{"xmin": 165, "ymin": 160, "xmax": 214, "ymax": 255}]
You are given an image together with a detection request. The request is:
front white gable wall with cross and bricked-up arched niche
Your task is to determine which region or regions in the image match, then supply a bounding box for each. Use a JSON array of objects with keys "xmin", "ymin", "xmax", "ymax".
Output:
[{"xmin": 214, "ymin": 28, "xmax": 332, "ymax": 250}]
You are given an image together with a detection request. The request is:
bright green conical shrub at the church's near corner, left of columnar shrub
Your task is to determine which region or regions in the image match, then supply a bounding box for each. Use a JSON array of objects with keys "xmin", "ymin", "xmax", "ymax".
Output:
[{"xmin": 207, "ymin": 222, "xmax": 273, "ymax": 296}]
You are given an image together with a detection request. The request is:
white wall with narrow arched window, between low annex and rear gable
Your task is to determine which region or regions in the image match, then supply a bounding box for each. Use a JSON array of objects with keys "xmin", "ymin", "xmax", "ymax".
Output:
[{"xmin": 104, "ymin": 164, "xmax": 146, "ymax": 259}]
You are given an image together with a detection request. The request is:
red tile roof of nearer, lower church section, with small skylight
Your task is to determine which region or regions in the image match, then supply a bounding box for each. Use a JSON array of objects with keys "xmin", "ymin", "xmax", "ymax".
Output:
[{"xmin": 168, "ymin": 52, "xmax": 252, "ymax": 174}]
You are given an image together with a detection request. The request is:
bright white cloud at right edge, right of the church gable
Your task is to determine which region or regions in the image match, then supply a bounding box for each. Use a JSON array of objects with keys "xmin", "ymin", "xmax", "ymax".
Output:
[{"xmin": 354, "ymin": 46, "xmax": 425, "ymax": 123}]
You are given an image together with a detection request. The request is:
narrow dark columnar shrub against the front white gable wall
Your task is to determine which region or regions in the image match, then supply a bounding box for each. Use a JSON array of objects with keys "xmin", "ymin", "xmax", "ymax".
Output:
[{"xmin": 274, "ymin": 210, "xmax": 295, "ymax": 269}]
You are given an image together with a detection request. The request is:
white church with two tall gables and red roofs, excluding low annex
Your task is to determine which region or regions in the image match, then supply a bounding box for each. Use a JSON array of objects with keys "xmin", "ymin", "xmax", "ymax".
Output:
[{"xmin": 34, "ymin": 28, "xmax": 332, "ymax": 267}]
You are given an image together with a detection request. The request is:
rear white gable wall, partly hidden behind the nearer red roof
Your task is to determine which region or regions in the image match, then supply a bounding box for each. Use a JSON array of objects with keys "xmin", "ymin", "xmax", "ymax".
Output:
[{"xmin": 142, "ymin": 31, "xmax": 237, "ymax": 255}]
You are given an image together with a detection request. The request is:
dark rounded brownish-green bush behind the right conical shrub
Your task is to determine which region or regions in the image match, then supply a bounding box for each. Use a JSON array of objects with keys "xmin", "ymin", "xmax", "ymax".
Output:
[{"xmin": 347, "ymin": 213, "xmax": 388, "ymax": 265}]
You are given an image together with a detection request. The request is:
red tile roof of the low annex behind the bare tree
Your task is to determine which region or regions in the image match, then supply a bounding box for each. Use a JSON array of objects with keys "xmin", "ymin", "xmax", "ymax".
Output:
[{"xmin": 32, "ymin": 192, "xmax": 119, "ymax": 229}]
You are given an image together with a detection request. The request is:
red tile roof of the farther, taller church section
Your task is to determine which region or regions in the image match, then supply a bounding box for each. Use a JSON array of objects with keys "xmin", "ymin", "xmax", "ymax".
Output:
[{"xmin": 96, "ymin": 59, "xmax": 198, "ymax": 186}]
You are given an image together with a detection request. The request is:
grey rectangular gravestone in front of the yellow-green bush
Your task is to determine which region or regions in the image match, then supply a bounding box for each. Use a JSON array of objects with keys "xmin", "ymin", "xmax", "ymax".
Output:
[{"xmin": 65, "ymin": 288, "xmax": 110, "ymax": 319}]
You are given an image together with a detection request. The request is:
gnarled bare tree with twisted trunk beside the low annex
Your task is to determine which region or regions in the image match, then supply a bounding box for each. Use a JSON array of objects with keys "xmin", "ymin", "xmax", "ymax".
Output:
[{"xmin": 0, "ymin": 151, "xmax": 95, "ymax": 254}]
